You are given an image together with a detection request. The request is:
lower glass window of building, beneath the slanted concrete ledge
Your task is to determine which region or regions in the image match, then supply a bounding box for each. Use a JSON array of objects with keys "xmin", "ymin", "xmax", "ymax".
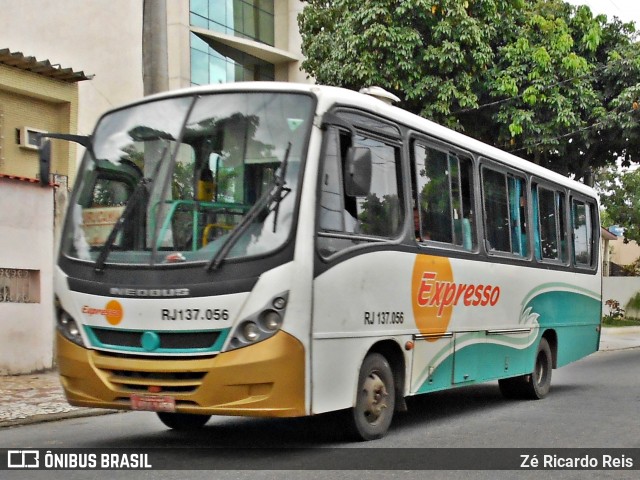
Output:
[{"xmin": 191, "ymin": 33, "xmax": 275, "ymax": 85}]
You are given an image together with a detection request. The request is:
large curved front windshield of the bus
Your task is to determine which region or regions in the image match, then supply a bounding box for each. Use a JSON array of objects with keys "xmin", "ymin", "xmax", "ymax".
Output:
[{"xmin": 62, "ymin": 92, "xmax": 313, "ymax": 268}]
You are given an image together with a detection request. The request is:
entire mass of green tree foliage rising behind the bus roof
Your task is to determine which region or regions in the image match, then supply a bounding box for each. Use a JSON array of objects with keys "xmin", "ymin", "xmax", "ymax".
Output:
[{"xmin": 299, "ymin": 0, "xmax": 640, "ymax": 179}]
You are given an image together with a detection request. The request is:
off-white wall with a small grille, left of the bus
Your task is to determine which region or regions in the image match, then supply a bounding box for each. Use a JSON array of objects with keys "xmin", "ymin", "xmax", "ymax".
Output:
[{"xmin": 0, "ymin": 177, "xmax": 54, "ymax": 375}]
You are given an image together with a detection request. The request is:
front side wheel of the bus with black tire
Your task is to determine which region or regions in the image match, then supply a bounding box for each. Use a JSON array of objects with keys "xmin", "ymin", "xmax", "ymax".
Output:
[{"xmin": 350, "ymin": 353, "xmax": 396, "ymax": 440}]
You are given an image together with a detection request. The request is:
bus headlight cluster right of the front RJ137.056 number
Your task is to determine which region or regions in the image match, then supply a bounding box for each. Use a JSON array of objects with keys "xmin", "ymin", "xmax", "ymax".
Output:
[{"xmin": 226, "ymin": 293, "xmax": 288, "ymax": 351}]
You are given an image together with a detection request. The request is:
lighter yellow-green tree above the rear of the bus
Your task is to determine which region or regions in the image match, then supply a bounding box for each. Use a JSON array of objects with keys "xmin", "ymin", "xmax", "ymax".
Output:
[{"xmin": 480, "ymin": 0, "xmax": 640, "ymax": 183}]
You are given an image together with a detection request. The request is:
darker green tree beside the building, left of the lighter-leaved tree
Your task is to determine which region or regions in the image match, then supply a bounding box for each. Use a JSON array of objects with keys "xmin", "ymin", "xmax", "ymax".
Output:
[{"xmin": 298, "ymin": 0, "xmax": 524, "ymax": 128}]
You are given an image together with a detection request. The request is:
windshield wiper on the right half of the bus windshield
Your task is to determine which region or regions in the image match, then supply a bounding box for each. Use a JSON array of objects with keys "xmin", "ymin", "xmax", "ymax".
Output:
[{"xmin": 205, "ymin": 142, "xmax": 291, "ymax": 272}]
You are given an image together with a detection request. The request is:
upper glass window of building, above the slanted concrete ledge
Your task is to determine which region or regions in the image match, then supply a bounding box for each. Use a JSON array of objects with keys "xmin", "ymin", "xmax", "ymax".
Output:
[{"xmin": 189, "ymin": 0, "xmax": 274, "ymax": 46}]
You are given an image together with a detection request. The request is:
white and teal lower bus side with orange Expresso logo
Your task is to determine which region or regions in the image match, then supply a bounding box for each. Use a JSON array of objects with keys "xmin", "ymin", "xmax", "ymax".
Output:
[{"xmin": 312, "ymin": 251, "xmax": 600, "ymax": 412}]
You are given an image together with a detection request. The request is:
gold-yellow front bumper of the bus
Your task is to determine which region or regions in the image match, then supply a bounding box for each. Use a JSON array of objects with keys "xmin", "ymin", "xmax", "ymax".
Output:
[{"xmin": 56, "ymin": 332, "xmax": 307, "ymax": 417}]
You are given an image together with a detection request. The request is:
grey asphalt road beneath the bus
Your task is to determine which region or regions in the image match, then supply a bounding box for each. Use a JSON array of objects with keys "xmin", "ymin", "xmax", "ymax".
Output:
[{"xmin": 0, "ymin": 348, "xmax": 640, "ymax": 479}]
